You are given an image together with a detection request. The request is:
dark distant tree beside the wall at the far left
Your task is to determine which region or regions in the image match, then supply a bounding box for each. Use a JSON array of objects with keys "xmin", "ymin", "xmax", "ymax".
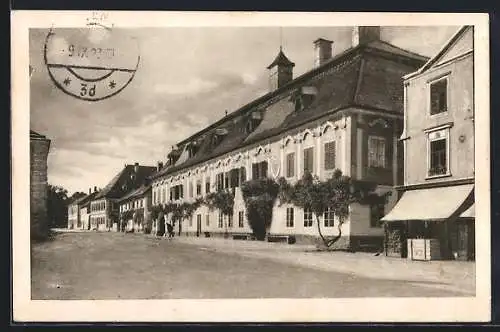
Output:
[{"xmin": 47, "ymin": 184, "xmax": 70, "ymax": 227}]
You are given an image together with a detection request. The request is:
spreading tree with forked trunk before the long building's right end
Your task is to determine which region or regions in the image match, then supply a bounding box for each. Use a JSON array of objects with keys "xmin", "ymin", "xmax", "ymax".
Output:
[{"xmin": 278, "ymin": 170, "xmax": 387, "ymax": 248}]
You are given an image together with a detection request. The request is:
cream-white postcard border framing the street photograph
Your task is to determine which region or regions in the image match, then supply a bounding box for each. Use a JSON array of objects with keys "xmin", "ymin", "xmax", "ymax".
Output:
[{"xmin": 11, "ymin": 11, "xmax": 491, "ymax": 322}]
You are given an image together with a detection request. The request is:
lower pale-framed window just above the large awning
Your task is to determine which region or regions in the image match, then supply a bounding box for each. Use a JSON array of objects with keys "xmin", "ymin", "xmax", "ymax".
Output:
[{"xmin": 428, "ymin": 129, "xmax": 448, "ymax": 176}]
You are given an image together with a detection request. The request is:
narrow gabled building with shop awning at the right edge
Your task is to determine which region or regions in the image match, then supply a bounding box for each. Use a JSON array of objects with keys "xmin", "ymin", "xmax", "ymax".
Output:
[{"xmin": 383, "ymin": 26, "xmax": 475, "ymax": 260}]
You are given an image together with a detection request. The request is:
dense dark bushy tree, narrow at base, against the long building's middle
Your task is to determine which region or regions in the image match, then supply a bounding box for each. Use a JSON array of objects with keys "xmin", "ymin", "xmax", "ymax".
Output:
[{"xmin": 241, "ymin": 178, "xmax": 280, "ymax": 240}]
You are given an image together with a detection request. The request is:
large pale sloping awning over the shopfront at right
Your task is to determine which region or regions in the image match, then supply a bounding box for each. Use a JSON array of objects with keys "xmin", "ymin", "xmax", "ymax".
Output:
[{"xmin": 381, "ymin": 184, "xmax": 474, "ymax": 222}]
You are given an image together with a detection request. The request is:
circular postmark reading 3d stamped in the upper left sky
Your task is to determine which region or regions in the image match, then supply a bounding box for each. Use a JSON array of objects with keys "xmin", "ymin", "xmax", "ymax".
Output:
[{"xmin": 44, "ymin": 27, "xmax": 140, "ymax": 101}]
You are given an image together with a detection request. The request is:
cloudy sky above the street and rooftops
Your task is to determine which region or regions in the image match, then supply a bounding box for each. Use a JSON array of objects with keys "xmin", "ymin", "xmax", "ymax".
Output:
[{"xmin": 30, "ymin": 26, "xmax": 459, "ymax": 194}]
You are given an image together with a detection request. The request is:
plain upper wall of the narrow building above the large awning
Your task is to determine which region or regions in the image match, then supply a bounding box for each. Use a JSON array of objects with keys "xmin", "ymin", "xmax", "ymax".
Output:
[{"xmin": 405, "ymin": 53, "xmax": 474, "ymax": 185}]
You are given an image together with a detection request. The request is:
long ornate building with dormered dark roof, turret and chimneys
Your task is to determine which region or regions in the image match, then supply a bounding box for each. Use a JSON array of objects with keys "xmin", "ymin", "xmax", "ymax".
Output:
[{"xmin": 148, "ymin": 27, "xmax": 428, "ymax": 248}]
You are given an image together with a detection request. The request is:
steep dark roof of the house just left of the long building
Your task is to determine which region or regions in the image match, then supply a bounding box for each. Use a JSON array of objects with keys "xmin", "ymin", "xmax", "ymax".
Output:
[{"xmin": 95, "ymin": 165, "xmax": 156, "ymax": 199}]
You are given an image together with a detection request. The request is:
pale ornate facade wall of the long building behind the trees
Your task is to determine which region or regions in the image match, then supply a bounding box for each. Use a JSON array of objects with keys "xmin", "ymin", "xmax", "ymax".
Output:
[{"xmin": 152, "ymin": 109, "xmax": 401, "ymax": 244}]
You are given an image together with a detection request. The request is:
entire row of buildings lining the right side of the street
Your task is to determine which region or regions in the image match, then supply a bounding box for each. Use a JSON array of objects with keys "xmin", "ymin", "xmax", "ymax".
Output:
[{"xmin": 69, "ymin": 27, "xmax": 474, "ymax": 259}]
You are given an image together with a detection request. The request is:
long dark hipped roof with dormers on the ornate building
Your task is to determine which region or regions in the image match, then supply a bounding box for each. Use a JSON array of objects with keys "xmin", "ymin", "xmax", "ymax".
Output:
[{"xmin": 152, "ymin": 40, "xmax": 428, "ymax": 178}]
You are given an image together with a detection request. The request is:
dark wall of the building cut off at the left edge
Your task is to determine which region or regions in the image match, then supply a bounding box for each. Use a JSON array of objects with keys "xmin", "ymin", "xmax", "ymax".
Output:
[{"xmin": 30, "ymin": 139, "xmax": 50, "ymax": 238}]
